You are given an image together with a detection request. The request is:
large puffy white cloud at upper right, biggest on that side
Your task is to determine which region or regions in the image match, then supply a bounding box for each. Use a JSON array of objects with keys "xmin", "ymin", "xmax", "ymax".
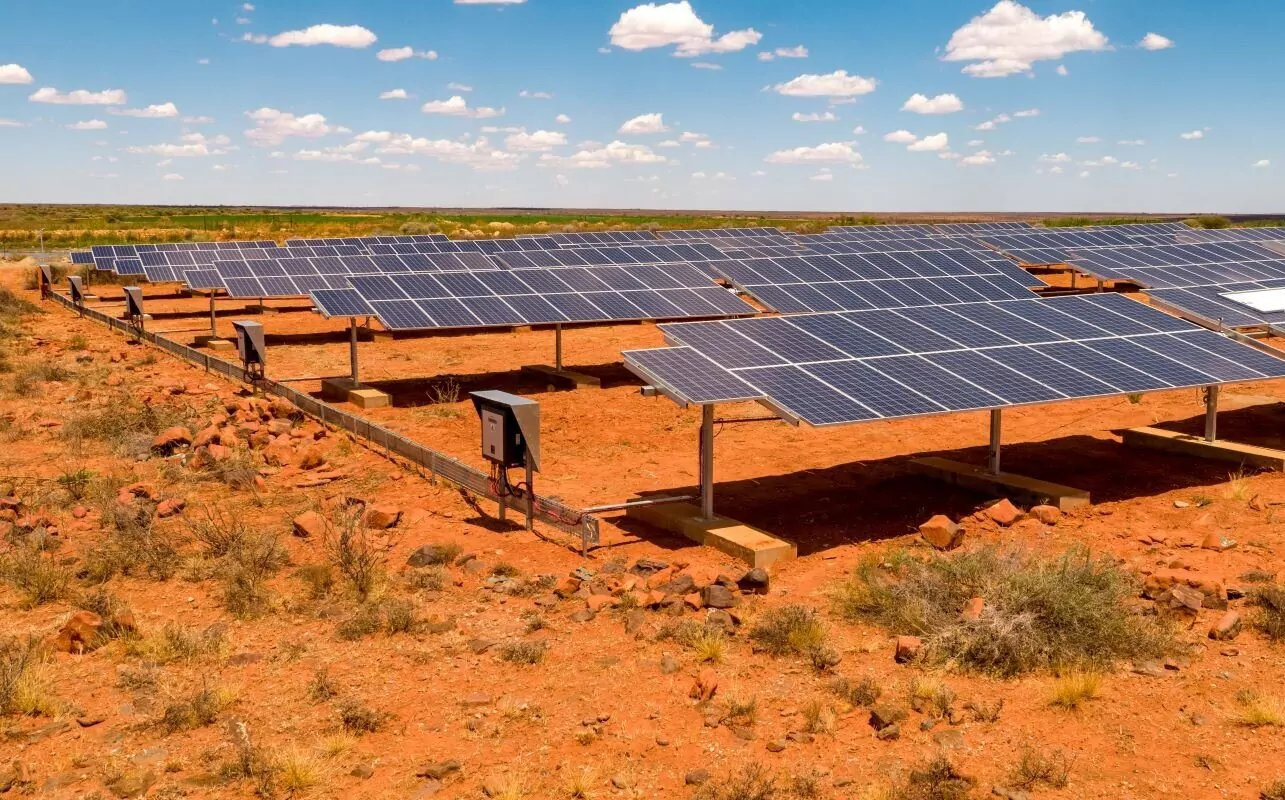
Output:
[{"xmin": 942, "ymin": 0, "xmax": 1108, "ymax": 78}]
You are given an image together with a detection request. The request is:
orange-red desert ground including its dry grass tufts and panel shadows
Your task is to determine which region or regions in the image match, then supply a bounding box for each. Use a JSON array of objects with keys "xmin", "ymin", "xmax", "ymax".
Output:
[{"xmin": 0, "ymin": 270, "xmax": 1285, "ymax": 800}]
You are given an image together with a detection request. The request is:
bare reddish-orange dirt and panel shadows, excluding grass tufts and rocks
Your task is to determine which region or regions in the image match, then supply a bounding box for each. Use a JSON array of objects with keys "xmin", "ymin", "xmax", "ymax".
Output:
[{"xmin": 0, "ymin": 265, "xmax": 1285, "ymax": 799}]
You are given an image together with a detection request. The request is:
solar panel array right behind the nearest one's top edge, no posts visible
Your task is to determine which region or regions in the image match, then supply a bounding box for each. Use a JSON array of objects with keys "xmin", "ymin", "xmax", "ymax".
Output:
[{"xmin": 707, "ymin": 250, "xmax": 1033, "ymax": 313}]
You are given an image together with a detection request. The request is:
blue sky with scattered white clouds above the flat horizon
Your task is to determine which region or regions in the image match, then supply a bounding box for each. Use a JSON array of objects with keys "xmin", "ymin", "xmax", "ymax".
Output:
[{"xmin": 0, "ymin": 0, "xmax": 1285, "ymax": 212}]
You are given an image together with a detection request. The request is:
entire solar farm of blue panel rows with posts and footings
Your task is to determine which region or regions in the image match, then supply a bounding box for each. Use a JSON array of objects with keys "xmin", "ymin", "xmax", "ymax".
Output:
[{"xmin": 60, "ymin": 223, "xmax": 1285, "ymax": 561}]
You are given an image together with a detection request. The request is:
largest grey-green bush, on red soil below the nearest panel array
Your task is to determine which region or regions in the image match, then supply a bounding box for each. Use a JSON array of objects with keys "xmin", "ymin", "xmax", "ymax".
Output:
[{"xmin": 834, "ymin": 548, "xmax": 1172, "ymax": 677}]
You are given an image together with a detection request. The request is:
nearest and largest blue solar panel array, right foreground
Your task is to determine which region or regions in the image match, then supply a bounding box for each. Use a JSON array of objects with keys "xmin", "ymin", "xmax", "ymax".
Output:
[{"xmin": 625, "ymin": 294, "xmax": 1285, "ymax": 426}]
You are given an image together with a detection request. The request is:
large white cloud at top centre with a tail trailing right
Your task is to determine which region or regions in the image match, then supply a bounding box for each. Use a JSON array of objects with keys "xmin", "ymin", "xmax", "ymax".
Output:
[{"xmin": 608, "ymin": 0, "xmax": 763, "ymax": 58}]
